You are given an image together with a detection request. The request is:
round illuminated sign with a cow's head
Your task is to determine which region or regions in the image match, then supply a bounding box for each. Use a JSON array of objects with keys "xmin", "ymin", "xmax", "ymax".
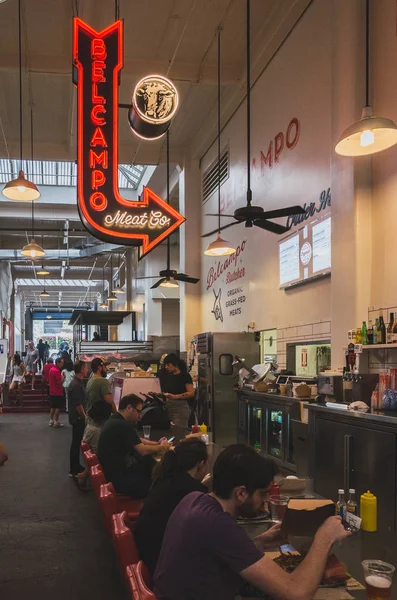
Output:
[{"xmin": 128, "ymin": 75, "xmax": 179, "ymax": 139}]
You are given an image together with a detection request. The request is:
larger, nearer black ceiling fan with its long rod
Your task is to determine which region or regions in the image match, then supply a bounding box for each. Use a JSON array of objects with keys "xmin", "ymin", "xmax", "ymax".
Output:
[{"xmin": 201, "ymin": 0, "xmax": 305, "ymax": 243}]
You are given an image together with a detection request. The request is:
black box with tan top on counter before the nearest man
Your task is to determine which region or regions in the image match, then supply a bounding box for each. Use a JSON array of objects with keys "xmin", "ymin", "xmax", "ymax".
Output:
[{"xmin": 281, "ymin": 499, "xmax": 335, "ymax": 537}]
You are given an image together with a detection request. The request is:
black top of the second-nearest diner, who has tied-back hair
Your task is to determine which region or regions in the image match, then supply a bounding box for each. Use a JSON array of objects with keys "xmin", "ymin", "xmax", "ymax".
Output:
[{"xmin": 134, "ymin": 471, "xmax": 208, "ymax": 575}]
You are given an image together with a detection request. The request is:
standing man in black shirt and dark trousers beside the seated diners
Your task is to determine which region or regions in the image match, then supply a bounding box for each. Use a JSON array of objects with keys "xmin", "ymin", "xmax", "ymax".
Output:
[{"xmin": 68, "ymin": 360, "xmax": 88, "ymax": 477}]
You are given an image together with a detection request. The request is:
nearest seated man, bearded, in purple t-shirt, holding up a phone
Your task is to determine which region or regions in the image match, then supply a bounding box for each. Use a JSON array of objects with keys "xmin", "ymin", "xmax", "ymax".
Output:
[{"xmin": 154, "ymin": 444, "xmax": 349, "ymax": 600}]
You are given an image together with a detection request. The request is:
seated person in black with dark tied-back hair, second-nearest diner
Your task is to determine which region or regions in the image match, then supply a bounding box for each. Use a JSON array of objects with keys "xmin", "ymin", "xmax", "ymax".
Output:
[{"xmin": 134, "ymin": 438, "xmax": 208, "ymax": 575}]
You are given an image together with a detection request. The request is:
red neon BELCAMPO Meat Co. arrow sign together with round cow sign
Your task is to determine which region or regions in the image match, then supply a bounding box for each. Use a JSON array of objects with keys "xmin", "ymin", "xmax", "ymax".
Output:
[{"xmin": 73, "ymin": 18, "xmax": 185, "ymax": 254}]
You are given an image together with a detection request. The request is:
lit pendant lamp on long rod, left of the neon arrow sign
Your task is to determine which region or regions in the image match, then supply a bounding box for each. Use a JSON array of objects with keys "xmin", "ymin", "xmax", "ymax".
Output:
[{"xmin": 2, "ymin": 0, "xmax": 41, "ymax": 202}]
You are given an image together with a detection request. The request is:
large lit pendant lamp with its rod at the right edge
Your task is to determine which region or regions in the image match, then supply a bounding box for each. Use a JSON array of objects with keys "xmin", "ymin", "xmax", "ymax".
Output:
[{"xmin": 335, "ymin": 0, "xmax": 397, "ymax": 156}]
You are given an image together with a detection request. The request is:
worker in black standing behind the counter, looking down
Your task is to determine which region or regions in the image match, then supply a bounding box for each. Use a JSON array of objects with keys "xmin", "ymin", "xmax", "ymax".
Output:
[{"xmin": 160, "ymin": 354, "xmax": 195, "ymax": 429}]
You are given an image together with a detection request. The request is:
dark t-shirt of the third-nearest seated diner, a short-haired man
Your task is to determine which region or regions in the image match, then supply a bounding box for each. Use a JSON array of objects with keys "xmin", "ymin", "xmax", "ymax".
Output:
[{"xmin": 97, "ymin": 413, "xmax": 142, "ymax": 481}]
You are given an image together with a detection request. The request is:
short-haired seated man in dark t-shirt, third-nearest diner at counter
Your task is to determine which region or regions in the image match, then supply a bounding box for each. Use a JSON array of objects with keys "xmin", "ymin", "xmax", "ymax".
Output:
[{"xmin": 97, "ymin": 394, "xmax": 170, "ymax": 498}]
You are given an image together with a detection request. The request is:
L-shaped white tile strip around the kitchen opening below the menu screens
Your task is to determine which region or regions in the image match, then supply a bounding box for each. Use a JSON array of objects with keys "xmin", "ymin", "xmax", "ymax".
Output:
[{"xmin": 277, "ymin": 321, "xmax": 331, "ymax": 369}]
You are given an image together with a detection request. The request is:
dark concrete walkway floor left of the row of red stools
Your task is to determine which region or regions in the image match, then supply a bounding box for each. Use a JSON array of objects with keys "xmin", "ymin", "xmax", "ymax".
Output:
[{"xmin": 0, "ymin": 414, "xmax": 129, "ymax": 600}]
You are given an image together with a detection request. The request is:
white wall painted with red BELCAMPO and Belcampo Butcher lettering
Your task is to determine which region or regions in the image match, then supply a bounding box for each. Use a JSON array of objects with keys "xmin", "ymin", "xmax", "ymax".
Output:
[{"xmin": 202, "ymin": 0, "xmax": 332, "ymax": 331}]
